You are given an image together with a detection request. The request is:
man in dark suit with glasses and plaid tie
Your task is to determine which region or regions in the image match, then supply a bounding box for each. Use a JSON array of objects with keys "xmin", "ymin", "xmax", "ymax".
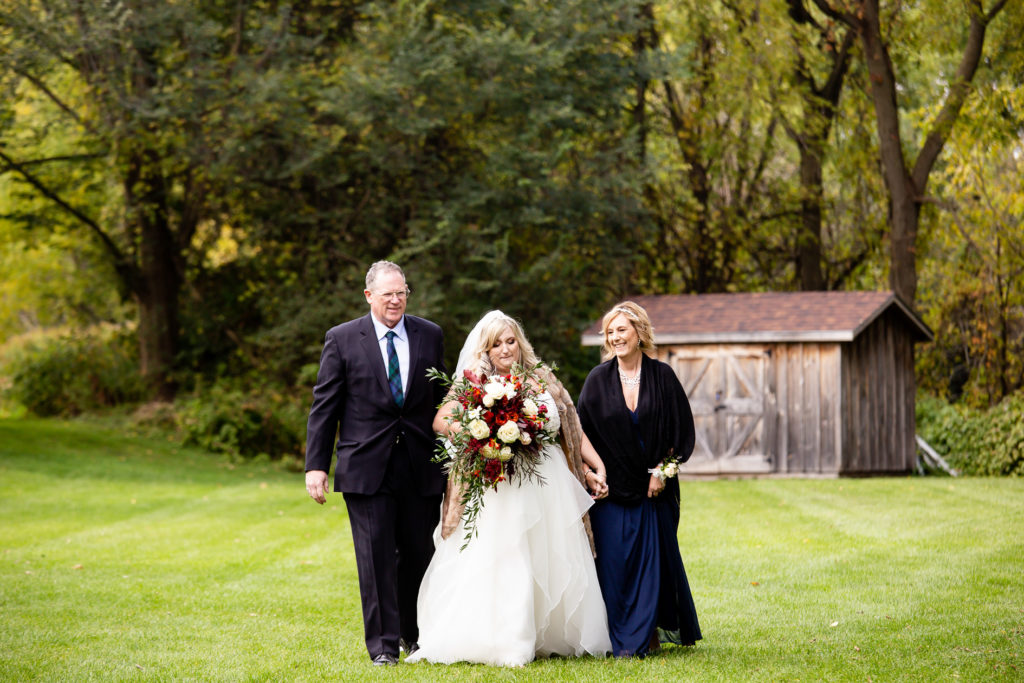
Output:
[{"xmin": 306, "ymin": 261, "xmax": 444, "ymax": 665}]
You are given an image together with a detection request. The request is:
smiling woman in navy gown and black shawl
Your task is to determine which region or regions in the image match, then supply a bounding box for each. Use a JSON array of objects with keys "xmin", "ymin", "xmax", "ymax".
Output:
[{"xmin": 579, "ymin": 301, "xmax": 701, "ymax": 657}]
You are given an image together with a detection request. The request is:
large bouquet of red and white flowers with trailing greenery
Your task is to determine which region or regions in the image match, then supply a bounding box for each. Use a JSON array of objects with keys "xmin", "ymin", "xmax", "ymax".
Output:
[{"xmin": 430, "ymin": 365, "xmax": 555, "ymax": 548}]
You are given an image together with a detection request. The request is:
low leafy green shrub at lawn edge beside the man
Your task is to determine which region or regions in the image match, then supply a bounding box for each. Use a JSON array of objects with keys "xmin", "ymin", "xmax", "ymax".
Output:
[{"xmin": 171, "ymin": 384, "xmax": 306, "ymax": 460}]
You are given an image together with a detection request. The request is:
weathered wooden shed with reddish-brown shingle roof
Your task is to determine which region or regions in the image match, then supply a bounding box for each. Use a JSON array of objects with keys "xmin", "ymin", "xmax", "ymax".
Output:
[{"xmin": 583, "ymin": 292, "xmax": 933, "ymax": 476}]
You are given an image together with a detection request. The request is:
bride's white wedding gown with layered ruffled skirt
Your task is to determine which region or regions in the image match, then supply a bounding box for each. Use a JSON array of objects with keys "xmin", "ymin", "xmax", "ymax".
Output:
[{"xmin": 406, "ymin": 392, "xmax": 611, "ymax": 667}]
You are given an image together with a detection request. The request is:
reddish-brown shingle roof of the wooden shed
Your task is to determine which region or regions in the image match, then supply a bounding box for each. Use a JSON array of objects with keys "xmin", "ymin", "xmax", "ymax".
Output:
[{"xmin": 583, "ymin": 292, "xmax": 932, "ymax": 346}]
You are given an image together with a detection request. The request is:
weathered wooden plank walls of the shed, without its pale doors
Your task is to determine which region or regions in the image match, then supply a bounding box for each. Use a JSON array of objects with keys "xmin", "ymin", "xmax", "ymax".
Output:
[{"xmin": 659, "ymin": 308, "xmax": 915, "ymax": 476}]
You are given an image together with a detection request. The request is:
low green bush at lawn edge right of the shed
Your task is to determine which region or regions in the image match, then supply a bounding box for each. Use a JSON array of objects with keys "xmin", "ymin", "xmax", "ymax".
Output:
[{"xmin": 918, "ymin": 393, "xmax": 1024, "ymax": 477}]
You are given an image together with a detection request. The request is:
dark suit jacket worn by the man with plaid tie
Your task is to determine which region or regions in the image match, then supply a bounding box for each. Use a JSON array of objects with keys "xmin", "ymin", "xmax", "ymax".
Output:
[{"xmin": 306, "ymin": 313, "xmax": 444, "ymax": 496}]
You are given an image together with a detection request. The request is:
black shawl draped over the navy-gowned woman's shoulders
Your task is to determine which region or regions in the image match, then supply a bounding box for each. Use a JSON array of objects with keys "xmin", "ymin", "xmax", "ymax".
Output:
[{"xmin": 577, "ymin": 355, "xmax": 694, "ymax": 503}]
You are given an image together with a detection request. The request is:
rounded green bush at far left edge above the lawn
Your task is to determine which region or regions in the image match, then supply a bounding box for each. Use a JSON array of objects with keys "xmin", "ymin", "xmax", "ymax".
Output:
[{"xmin": 0, "ymin": 326, "xmax": 145, "ymax": 416}]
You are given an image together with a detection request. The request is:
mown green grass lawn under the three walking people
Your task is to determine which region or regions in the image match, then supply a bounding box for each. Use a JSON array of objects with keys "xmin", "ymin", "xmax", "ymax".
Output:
[{"xmin": 0, "ymin": 420, "xmax": 1024, "ymax": 681}]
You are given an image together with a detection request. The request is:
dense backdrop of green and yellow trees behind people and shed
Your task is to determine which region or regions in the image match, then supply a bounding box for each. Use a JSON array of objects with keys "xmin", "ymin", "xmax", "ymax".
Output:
[{"xmin": 0, "ymin": 0, "xmax": 1024, "ymax": 401}]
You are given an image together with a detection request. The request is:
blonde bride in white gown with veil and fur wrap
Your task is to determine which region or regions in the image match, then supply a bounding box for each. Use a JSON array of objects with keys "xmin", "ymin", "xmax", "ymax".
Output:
[{"xmin": 406, "ymin": 310, "xmax": 611, "ymax": 667}]
